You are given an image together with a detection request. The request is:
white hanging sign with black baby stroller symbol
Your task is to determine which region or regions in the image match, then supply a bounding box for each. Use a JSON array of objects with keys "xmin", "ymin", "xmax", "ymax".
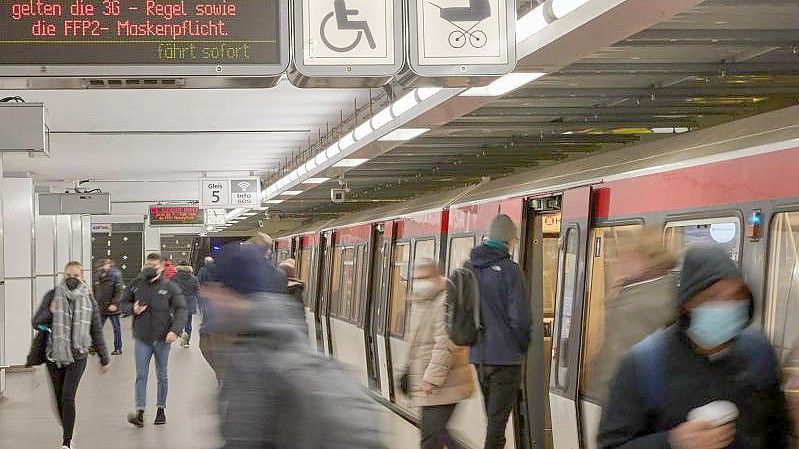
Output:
[{"xmin": 408, "ymin": 0, "xmax": 516, "ymax": 77}]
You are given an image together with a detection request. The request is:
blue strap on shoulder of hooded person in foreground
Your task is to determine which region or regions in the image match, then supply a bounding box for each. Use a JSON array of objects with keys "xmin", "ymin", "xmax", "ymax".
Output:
[{"xmin": 632, "ymin": 330, "xmax": 666, "ymax": 411}]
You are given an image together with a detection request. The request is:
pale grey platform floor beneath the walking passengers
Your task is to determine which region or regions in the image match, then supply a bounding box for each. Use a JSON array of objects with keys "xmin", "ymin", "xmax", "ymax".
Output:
[{"xmin": 0, "ymin": 320, "xmax": 418, "ymax": 449}]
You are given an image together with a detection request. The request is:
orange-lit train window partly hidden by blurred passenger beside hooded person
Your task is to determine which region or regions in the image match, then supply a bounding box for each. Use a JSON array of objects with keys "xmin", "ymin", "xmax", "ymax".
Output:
[{"xmin": 580, "ymin": 224, "xmax": 641, "ymax": 401}]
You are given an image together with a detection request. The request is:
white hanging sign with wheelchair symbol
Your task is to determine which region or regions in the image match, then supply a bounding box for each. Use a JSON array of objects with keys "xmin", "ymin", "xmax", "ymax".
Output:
[{"xmin": 293, "ymin": 0, "xmax": 405, "ymax": 86}]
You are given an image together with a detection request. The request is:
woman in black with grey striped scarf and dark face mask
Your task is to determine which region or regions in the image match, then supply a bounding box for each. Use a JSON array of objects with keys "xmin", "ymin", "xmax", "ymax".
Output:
[{"xmin": 33, "ymin": 262, "xmax": 110, "ymax": 449}]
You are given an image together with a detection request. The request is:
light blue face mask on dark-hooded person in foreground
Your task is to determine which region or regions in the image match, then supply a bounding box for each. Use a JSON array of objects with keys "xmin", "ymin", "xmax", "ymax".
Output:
[{"xmin": 688, "ymin": 301, "xmax": 749, "ymax": 349}]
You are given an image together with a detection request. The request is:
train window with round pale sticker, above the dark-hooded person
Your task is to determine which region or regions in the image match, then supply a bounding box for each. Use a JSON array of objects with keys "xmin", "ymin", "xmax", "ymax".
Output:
[{"xmin": 665, "ymin": 217, "xmax": 742, "ymax": 261}]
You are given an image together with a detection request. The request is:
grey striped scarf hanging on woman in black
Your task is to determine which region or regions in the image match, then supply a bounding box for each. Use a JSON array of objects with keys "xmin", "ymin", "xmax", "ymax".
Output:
[{"xmin": 47, "ymin": 281, "xmax": 94, "ymax": 368}]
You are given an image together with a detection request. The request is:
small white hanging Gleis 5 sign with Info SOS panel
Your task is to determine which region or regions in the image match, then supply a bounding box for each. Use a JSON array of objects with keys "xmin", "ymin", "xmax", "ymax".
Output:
[{"xmin": 200, "ymin": 178, "xmax": 261, "ymax": 209}]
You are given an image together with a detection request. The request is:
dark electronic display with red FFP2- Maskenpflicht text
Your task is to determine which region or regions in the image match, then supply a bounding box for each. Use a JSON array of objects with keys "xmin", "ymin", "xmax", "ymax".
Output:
[{"xmin": 0, "ymin": 0, "xmax": 289, "ymax": 77}]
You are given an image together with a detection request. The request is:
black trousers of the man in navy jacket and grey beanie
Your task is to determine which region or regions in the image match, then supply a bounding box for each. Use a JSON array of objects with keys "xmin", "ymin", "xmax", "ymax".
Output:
[{"xmin": 477, "ymin": 365, "xmax": 522, "ymax": 449}]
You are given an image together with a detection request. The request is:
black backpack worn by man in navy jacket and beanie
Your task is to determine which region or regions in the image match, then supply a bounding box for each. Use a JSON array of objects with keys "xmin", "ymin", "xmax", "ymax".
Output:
[{"xmin": 446, "ymin": 267, "xmax": 482, "ymax": 346}]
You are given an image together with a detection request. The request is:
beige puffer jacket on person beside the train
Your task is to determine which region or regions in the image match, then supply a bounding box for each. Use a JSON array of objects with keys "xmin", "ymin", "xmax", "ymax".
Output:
[{"xmin": 408, "ymin": 278, "xmax": 474, "ymax": 407}]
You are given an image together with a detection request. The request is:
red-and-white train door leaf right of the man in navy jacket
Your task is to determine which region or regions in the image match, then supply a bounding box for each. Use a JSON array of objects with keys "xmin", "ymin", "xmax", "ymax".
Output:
[{"xmin": 549, "ymin": 187, "xmax": 592, "ymax": 449}]
